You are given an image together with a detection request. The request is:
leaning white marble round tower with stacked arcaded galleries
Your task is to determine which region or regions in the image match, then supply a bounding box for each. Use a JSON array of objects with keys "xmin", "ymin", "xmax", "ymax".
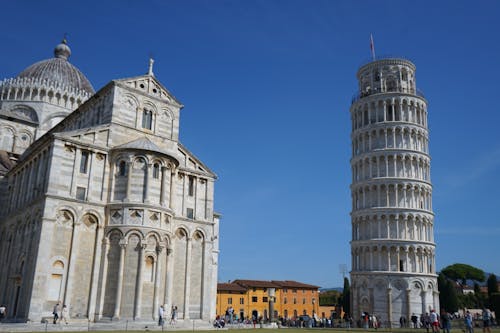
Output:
[{"xmin": 350, "ymin": 59, "xmax": 439, "ymax": 326}]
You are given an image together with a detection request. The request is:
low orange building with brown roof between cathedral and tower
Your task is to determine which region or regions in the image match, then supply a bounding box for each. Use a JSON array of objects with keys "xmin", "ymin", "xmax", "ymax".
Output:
[{"xmin": 216, "ymin": 280, "xmax": 319, "ymax": 320}]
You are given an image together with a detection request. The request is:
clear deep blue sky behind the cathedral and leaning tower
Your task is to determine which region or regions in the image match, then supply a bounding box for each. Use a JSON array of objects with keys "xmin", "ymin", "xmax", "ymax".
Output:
[{"xmin": 0, "ymin": 0, "xmax": 500, "ymax": 287}]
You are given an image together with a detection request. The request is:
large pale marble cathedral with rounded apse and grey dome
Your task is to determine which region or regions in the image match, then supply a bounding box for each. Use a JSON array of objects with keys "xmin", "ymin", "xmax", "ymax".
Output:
[{"xmin": 0, "ymin": 40, "xmax": 219, "ymax": 322}]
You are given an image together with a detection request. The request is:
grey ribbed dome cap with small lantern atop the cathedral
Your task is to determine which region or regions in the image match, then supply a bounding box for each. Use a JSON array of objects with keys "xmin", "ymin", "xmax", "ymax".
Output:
[{"xmin": 17, "ymin": 39, "xmax": 95, "ymax": 95}]
